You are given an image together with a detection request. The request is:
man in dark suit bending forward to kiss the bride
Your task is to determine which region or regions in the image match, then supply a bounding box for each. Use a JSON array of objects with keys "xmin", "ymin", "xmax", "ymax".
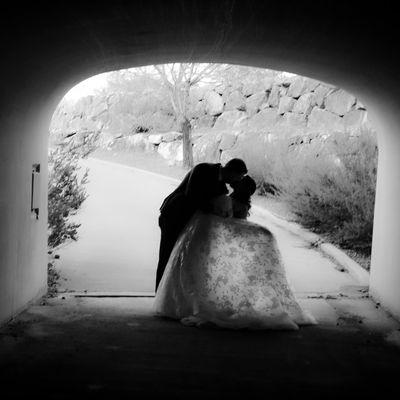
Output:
[{"xmin": 156, "ymin": 158, "xmax": 247, "ymax": 291}]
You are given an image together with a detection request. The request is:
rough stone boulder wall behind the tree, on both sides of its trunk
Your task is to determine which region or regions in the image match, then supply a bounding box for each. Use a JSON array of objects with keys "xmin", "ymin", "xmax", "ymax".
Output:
[{"xmin": 52, "ymin": 73, "xmax": 370, "ymax": 164}]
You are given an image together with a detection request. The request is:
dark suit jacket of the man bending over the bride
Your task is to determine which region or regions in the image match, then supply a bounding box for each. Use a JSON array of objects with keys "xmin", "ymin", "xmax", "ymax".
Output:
[{"xmin": 160, "ymin": 163, "xmax": 229, "ymax": 219}]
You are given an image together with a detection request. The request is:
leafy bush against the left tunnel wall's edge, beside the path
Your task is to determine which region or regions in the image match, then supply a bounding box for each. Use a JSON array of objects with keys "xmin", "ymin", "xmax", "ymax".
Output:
[{"xmin": 48, "ymin": 148, "xmax": 88, "ymax": 249}]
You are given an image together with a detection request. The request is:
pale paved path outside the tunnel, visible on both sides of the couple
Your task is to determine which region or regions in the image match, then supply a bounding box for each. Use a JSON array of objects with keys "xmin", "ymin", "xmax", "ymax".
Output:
[{"xmin": 58, "ymin": 159, "xmax": 356, "ymax": 295}]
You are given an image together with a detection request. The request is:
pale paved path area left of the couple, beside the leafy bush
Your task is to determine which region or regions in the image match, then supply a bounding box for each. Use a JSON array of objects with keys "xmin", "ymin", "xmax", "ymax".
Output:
[{"xmin": 58, "ymin": 159, "xmax": 176, "ymax": 292}]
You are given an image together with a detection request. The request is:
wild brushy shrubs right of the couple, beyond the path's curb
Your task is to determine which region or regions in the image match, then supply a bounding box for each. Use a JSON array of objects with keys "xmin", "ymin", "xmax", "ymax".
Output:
[{"xmin": 242, "ymin": 130, "xmax": 378, "ymax": 254}]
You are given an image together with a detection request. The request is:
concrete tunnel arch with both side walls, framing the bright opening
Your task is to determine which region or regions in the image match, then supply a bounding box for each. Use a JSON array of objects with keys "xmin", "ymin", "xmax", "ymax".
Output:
[{"xmin": 0, "ymin": 0, "xmax": 400, "ymax": 321}]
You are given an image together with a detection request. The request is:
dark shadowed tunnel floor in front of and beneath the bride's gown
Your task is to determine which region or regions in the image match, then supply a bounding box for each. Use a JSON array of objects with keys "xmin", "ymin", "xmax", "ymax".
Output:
[{"xmin": 0, "ymin": 290, "xmax": 400, "ymax": 399}]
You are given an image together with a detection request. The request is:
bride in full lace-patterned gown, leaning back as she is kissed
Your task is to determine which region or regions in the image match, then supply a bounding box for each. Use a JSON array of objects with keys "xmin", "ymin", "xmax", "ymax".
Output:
[{"xmin": 154, "ymin": 176, "xmax": 316, "ymax": 330}]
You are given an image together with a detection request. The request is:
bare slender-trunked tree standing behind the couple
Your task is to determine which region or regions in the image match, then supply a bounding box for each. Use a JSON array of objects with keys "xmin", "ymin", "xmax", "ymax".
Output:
[{"xmin": 153, "ymin": 63, "xmax": 226, "ymax": 168}]
